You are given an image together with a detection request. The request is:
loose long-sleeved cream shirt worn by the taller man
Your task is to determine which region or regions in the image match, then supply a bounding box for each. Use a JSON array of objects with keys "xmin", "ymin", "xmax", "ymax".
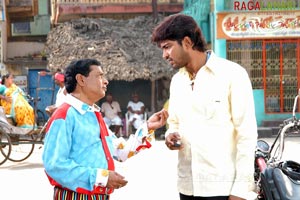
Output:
[{"xmin": 166, "ymin": 51, "xmax": 257, "ymax": 198}]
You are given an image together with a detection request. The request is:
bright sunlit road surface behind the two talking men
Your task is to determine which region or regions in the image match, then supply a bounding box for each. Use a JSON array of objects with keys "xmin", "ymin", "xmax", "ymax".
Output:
[{"xmin": 0, "ymin": 137, "xmax": 300, "ymax": 200}]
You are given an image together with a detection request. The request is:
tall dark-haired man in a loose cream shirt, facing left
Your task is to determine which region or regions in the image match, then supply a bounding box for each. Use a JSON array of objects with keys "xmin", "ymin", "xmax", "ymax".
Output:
[{"xmin": 151, "ymin": 14, "xmax": 257, "ymax": 200}]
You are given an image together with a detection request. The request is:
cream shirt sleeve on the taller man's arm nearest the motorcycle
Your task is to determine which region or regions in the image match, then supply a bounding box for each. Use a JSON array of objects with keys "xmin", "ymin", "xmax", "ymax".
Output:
[{"xmin": 230, "ymin": 67, "xmax": 257, "ymax": 198}]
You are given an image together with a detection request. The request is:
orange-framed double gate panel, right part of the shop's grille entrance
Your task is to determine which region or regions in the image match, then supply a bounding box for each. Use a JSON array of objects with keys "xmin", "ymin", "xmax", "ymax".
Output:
[{"xmin": 263, "ymin": 40, "xmax": 299, "ymax": 113}]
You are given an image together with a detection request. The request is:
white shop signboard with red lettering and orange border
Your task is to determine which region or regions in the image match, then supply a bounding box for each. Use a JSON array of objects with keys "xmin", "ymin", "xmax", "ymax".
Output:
[{"xmin": 217, "ymin": 11, "xmax": 300, "ymax": 39}]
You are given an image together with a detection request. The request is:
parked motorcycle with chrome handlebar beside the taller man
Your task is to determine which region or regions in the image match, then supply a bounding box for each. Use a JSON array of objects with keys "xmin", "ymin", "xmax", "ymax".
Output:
[{"xmin": 254, "ymin": 90, "xmax": 300, "ymax": 200}]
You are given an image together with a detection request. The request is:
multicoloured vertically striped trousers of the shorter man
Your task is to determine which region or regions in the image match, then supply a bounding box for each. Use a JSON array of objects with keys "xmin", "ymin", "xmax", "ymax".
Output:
[{"xmin": 53, "ymin": 187, "xmax": 109, "ymax": 200}]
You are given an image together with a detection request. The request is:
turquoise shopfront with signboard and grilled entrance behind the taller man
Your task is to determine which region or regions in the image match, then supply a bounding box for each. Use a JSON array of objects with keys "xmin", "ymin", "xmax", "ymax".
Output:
[{"xmin": 210, "ymin": 0, "xmax": 300, "ymax": 126}]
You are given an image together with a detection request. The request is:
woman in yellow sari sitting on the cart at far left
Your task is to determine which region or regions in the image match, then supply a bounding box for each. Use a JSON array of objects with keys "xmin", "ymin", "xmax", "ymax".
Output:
[{"xmin": 0, "ymin": 74, "xmax": 35, "ymax": 128}]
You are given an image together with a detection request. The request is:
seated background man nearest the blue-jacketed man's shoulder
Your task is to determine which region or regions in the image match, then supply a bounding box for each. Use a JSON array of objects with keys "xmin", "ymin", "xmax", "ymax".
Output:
[{"xmin": 101, "ymin": 93, "xmax": 122, "ymax": 136}]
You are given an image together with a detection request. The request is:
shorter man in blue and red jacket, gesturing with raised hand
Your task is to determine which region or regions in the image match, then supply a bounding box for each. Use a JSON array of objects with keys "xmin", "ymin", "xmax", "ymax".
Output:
[{"xmin": 43, "ymin": 59, "xmax": 168, "ymax": 200}]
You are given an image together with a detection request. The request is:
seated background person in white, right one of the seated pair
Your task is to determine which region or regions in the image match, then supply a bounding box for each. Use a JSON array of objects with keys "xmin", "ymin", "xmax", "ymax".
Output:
[{"xmin": 127, "ymin": 93, "xmax": 145, "ymax": 129}]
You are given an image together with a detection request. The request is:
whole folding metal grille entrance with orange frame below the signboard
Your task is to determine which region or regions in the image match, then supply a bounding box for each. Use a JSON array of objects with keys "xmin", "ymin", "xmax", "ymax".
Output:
[{"xmin": 226, "ymin": 39, "xmax": 300, "ymax": 113}]
